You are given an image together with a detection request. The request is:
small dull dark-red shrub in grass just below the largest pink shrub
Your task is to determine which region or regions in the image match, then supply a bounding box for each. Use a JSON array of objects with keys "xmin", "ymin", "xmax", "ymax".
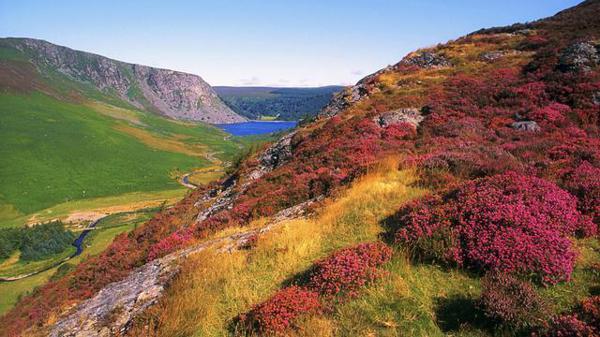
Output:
[{"xmin": 481, "ymin": 274, "xmax": 549, "ymax": 330}]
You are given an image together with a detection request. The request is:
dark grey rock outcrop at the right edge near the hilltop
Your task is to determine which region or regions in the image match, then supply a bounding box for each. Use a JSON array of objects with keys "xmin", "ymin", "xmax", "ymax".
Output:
[{"xmin": 559, "ymin": 42, "xmax": 600, "ymax": 72}]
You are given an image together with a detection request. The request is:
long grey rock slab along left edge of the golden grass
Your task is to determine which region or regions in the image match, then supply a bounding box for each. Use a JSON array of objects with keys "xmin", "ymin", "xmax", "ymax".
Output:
[{"xmin": 49, "ymin": 200, "xmax": 314, "ymax": 337}]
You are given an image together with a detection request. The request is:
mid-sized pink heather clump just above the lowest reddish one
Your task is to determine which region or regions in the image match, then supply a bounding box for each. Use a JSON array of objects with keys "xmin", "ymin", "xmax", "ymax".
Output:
[{"xmin": 308, "ymin": 242, "xmax": 392, "ymax": 297}]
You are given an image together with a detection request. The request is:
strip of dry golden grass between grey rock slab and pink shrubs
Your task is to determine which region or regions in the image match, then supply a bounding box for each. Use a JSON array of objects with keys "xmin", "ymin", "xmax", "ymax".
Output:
[{"xmin": 131, "ymin": 160, "xmax": 425, "ymax": 337}]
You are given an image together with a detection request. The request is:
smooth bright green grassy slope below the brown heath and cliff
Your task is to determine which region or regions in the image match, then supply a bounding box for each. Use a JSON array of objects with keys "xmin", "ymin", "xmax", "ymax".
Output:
[{"xmin": 0, "ymin": 93, "xmax": 250, "ymax": 223}]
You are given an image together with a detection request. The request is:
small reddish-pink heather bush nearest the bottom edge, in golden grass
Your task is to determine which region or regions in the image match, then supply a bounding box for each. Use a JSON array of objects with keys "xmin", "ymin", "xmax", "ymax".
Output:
[{"xmin": 240, "ymin": 286, "xmax": 321, "ymax": 335}]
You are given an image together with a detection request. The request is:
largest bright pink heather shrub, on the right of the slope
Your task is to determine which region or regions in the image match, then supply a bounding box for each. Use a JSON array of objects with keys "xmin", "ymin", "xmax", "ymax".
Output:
[{"xmin": 394, "ymin": 172, "xmax": 595, "ymax": 284}]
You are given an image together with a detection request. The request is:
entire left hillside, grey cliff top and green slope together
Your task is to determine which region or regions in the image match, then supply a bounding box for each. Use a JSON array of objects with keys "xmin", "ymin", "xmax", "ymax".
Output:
[{"xmin": 0, "ymin": 39, "xmax": 255, "ymax": 227}]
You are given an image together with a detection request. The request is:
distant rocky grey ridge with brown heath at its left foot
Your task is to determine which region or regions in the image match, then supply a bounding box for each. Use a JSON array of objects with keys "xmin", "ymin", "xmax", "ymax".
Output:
[{"xmin": 0, "ymin": 38, "xmax": 245, "ymax": 124}]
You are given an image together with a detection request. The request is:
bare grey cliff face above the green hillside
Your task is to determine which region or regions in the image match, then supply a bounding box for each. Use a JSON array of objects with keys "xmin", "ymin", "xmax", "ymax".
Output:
[{"xmin": 4, "ymin": 39, "xmax": 246, "ymax": 124}]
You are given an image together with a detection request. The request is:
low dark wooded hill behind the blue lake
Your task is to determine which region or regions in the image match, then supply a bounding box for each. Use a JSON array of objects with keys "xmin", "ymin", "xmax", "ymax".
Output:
[{"xmin": 214, "ymin": 86, "xmax": 344, "ymax": 120}]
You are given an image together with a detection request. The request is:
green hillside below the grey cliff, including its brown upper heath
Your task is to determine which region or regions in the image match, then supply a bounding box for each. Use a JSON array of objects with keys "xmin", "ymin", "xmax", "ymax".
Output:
[{"xmin": 0, "ymin": 39, "xmax": 257, "ymax": 227}]
